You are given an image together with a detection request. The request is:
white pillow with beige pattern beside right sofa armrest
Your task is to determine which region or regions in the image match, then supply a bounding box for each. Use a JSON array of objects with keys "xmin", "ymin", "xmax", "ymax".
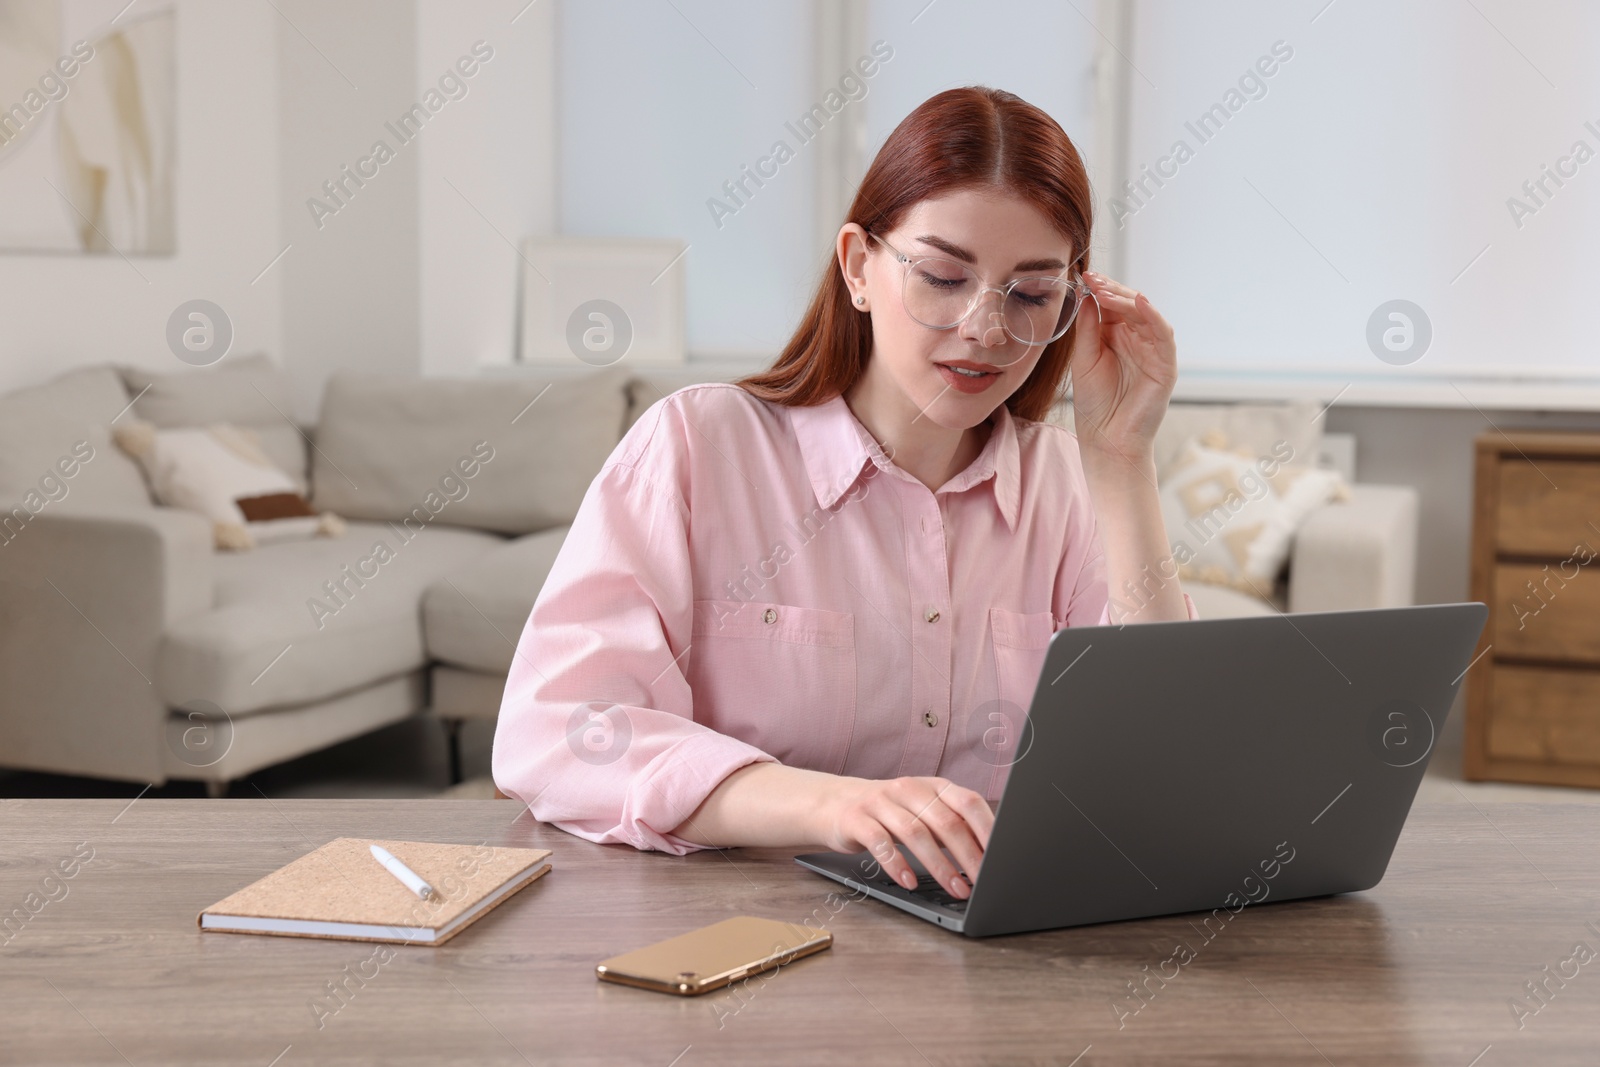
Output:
[{"xmin": 1160, "ymin": 430, "xmax": 1350, "ymax": 598}]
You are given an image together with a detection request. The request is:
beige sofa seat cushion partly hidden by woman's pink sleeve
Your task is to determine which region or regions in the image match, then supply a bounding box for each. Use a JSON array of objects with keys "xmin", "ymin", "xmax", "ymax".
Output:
[{"xmin": 422, "ymin": 526, "xmax": 570, "ymax": 677}]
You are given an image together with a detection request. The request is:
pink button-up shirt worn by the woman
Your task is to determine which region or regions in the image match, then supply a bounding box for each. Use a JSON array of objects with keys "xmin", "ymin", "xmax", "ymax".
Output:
[{"xmin": 494, "ymin": 384, "xmax": 1194, "ymax": 854}]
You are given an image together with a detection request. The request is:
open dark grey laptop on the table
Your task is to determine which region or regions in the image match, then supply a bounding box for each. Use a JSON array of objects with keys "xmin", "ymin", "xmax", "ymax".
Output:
[{"xmin": 795, "ymin": 603, "xmax": 1488, "ymax": 937}]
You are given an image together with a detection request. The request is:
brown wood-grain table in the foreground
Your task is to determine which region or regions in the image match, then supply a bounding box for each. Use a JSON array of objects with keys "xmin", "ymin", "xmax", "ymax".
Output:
[{"xmin": 0, "ymin": 800, "xmax": 1600, "ymax": 1067}]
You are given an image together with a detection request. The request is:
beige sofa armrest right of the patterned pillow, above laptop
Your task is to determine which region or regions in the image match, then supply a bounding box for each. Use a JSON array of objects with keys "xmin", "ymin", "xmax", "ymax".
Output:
[{"xmin": 1290, "ymin": 485, "xmax": 1418, "ymax": 611}]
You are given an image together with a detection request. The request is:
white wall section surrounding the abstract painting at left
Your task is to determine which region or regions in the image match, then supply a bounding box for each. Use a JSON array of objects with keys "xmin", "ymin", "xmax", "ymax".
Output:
[{"xmin": 0, "ymin": 0, "xmax": 283, "ymax": 396}]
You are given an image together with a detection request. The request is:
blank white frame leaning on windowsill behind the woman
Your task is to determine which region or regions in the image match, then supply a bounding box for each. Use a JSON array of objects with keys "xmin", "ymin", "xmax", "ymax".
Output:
[{"xmin": 518, "ymin": 237, "xmax": 685, "ymax": 368}]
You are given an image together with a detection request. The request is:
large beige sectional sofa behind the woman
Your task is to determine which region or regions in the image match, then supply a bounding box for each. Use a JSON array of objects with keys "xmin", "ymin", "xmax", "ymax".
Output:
[{"xmin": 0, "ymin": 357, "xmax": 1416, "ymax": 793}]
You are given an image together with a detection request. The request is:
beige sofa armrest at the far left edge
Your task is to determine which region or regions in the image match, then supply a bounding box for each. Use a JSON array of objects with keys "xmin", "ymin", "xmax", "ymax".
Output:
[{"xmin": 0, "ymin": 507, "xmax": 214, "ymax": 782}]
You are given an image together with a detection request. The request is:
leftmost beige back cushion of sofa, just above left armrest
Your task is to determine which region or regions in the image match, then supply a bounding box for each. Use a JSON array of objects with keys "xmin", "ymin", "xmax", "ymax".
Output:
[{"xmin": 0, "ymin": 366, "xmax": 152, "ymax": 518}]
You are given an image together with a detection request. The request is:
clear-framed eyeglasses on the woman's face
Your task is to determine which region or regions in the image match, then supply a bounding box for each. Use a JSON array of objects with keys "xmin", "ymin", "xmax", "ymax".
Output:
[{"xmin": 867, "ymin": 234, "xmax": 1088, "ymax": 355}]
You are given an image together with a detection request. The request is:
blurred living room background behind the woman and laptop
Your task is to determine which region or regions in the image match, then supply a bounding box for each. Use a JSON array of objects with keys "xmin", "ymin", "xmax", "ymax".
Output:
[{"xmin": 0, "ymin": 0, "xmax": 1600, "ymax": 803}]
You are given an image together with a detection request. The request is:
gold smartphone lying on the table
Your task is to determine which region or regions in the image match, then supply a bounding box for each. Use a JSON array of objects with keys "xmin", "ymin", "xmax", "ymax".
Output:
[{"xmin": 595, "ymin": 915, "xmax": 834, "ymax": 997}]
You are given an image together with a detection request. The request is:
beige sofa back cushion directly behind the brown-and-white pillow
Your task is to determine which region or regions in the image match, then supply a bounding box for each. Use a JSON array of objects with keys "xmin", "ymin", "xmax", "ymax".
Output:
[{"xmin": 117, "ymin": 354, "xmax": 307, "ymax": 493}]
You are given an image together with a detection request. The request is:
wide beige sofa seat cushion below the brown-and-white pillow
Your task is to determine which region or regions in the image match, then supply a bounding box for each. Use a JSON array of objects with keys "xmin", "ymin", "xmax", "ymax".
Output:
[{"xmin": 155, "ymin": 523, "xmax": 504, "ymax": 717}]
